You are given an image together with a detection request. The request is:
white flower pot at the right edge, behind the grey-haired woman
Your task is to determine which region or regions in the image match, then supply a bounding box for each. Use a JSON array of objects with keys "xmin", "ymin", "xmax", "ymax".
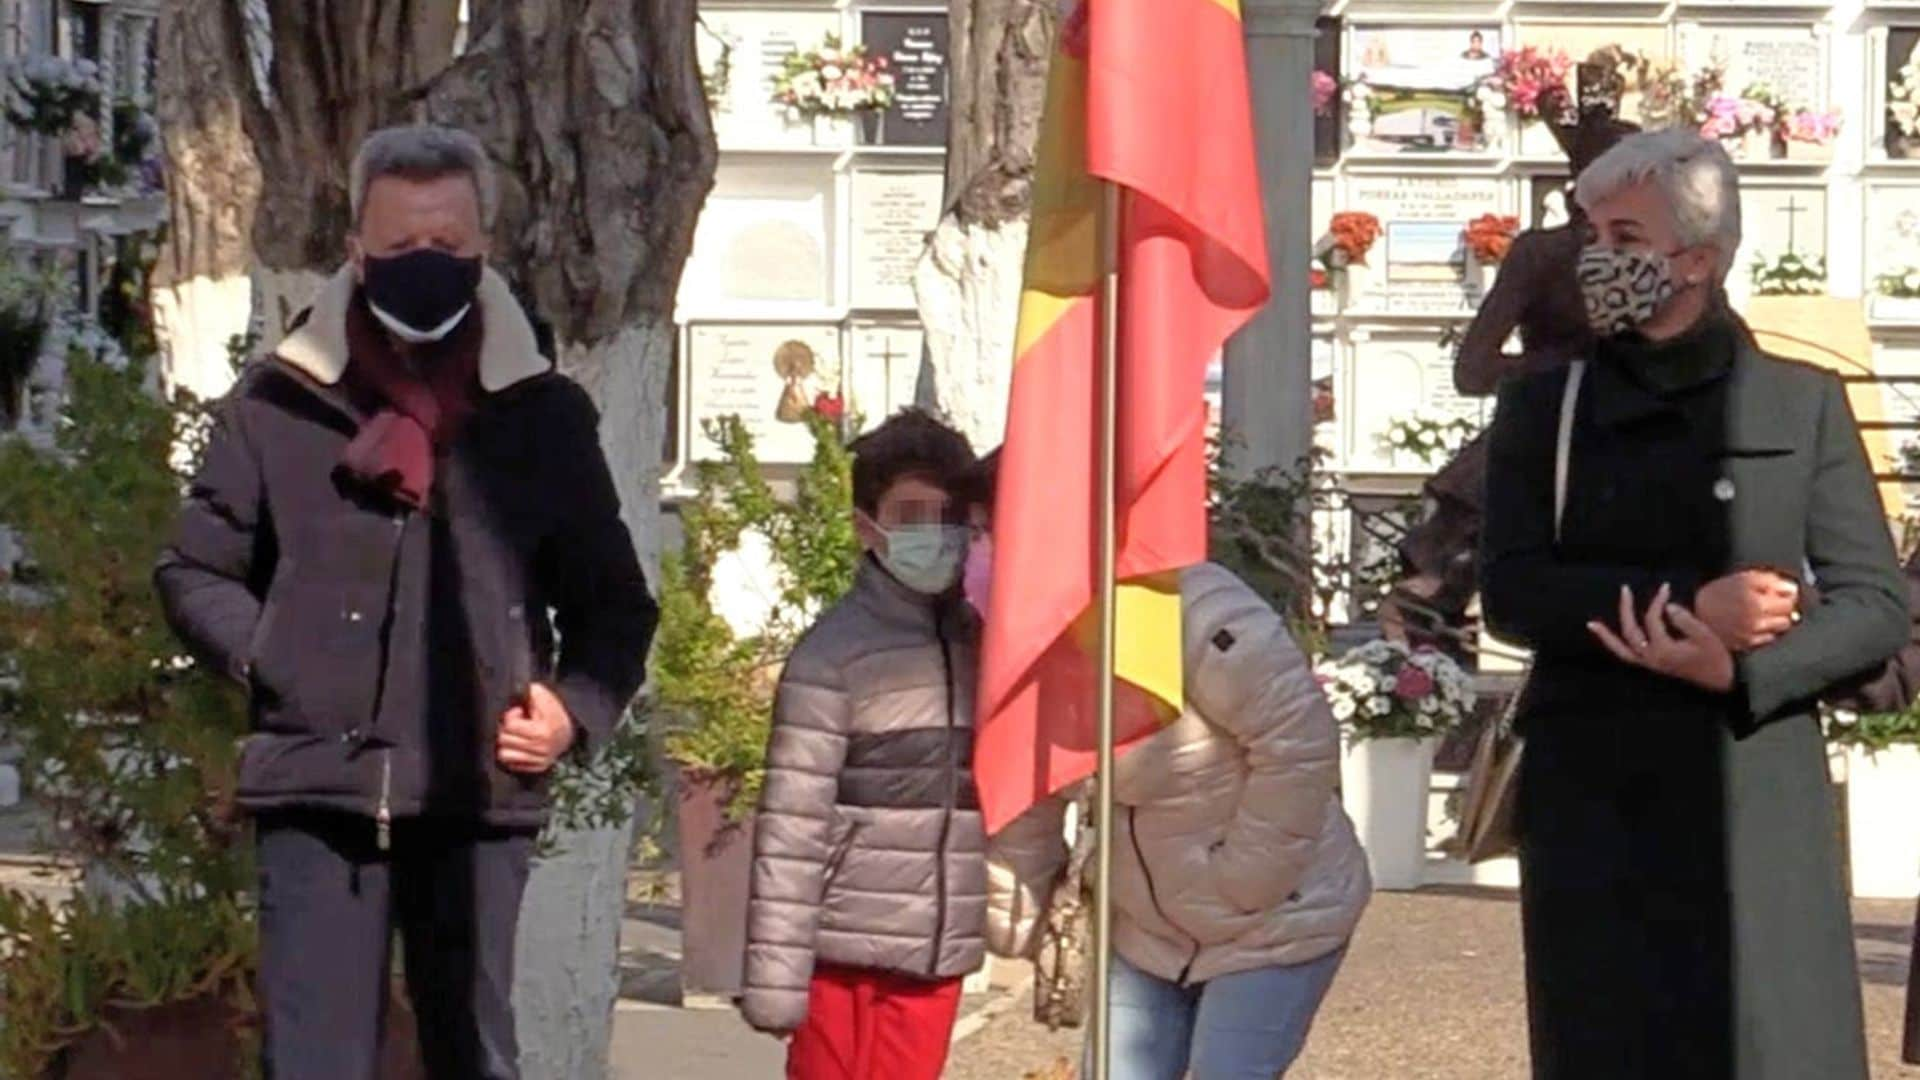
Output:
[{"xmin": 1847, "ymin": 746, "xmax": 1920, "ymax": 899}]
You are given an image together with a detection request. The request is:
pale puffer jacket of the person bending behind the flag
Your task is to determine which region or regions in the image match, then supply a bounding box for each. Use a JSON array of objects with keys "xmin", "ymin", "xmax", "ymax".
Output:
[{"xmin": 987, "ymin": 565, "xmax": 1373, "ymax": 984}]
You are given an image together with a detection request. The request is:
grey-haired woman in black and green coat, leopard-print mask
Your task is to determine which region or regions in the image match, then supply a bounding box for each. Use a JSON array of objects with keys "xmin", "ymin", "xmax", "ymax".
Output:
[{"xmin": 1482, "ymin": 131, "xmax": 1908, "ymax": 1080}]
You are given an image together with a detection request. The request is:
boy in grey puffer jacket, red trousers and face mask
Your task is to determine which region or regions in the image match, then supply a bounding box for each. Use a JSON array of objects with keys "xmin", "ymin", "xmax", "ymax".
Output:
[{"xmin": 741, "ymin": 411, "xmax": 987, "ymax": 1080}]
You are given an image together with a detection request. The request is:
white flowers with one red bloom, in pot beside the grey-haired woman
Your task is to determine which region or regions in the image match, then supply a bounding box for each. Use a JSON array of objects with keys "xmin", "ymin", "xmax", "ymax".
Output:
[{"xmin": 1315, "ymin": 640, "xmax": 1475, "ymax": 740}]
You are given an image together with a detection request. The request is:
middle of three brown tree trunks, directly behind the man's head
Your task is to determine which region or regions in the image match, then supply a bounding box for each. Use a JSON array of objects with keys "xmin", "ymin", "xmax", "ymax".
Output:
[{"xmin": 219, "ymin": 0, "xmax": 459, "ymax": 346}]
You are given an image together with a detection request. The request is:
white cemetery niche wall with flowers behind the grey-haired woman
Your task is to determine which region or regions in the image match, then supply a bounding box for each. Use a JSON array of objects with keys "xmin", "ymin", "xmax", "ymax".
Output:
[{"xmin": 1302, "ymin": 0, "xmax": 1920, "ymax": 638}]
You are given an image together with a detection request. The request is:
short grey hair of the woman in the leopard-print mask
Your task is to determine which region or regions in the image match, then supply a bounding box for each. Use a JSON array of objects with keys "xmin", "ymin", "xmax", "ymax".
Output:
[{"xmin": 1574, "ymin": 127, "xmax": 1740, "ymax": 279}]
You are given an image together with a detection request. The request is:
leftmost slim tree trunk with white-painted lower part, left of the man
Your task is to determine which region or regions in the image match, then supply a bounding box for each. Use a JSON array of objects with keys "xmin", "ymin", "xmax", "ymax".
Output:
[{"xmin": 152, "ymin": 0, "xmax": 261, "ymax": 398}]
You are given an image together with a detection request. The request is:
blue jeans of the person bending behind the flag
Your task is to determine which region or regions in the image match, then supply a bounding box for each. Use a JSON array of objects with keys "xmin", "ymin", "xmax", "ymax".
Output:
[{"xmin": 1081, "ymin": 949, "xmax": 1346, "ymax": 1080}]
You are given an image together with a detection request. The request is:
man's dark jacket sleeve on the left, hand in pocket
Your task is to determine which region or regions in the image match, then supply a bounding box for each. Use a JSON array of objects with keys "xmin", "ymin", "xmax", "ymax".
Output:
[{"xmin": 154, "ymin": 382, "xmax": 276, "ymax": 682}]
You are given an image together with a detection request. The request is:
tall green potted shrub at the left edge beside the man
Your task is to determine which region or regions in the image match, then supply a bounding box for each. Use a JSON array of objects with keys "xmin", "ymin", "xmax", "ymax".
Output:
[{"xmin": 0, "ymin": 309, "xmax": 437, "ymax": 1080}]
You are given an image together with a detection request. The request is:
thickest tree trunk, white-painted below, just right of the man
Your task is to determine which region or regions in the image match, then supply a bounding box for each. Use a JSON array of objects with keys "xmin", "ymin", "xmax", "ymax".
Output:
[{"xmin": 426, "ymin": 0, "xmax": 718, "ymax": 1080}]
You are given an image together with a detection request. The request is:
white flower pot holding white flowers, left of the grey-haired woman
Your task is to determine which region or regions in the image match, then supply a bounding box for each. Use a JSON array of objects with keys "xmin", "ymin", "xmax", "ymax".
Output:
[{"xmin": 1340, "ymin": 738, "xmax": 1440, "ymax": 890}]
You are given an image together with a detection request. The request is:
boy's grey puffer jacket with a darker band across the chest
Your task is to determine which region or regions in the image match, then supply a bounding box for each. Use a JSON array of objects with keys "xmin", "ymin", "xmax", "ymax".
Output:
[{"xmin": 741, "ymin": 559, "xmax": 987, "ymax": 1032}]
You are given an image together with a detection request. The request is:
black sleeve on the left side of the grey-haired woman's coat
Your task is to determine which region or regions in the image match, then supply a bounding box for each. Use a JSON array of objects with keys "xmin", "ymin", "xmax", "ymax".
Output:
[{"xmin": 1480, "ymin": 369, "xmax": 1703, "ymax": 657}]
